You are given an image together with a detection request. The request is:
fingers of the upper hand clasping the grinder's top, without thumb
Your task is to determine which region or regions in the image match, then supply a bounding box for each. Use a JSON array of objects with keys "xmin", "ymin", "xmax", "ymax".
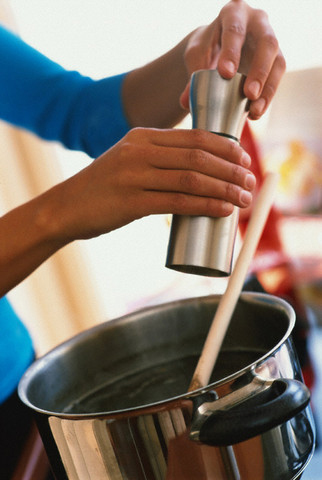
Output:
[{"xmin": 199, "ymin": 1, "xmax": 286, "ymax": 119}]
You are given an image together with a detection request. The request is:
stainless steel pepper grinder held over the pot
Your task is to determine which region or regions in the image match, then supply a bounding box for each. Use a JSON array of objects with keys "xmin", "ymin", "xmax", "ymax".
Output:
[{"xmin": 166, "ymin": 70, "xmax": 248, "ymax": 277}]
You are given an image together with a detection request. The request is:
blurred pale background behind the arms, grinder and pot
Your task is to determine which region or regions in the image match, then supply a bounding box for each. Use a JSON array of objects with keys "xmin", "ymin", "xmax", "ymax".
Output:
[{"xmin": 0, "ymin": 0, "xmax": 322, "ymax": 480}]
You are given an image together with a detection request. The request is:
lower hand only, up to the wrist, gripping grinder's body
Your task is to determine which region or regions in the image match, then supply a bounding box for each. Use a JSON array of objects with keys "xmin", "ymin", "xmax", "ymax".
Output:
[{"xmin": 55, "ymin": 128, "xmax": 255, "ymax": 243}]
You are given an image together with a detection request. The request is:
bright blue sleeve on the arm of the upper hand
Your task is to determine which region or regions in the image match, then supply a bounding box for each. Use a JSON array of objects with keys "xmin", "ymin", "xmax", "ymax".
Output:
[{"xmin": 0, "ymin": 25, "xmax": 130, "ymax": 157}]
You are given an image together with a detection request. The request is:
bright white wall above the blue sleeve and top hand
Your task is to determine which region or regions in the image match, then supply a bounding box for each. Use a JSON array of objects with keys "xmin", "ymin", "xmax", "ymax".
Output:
[{"xmin": 8, "ymin": 0, "xmax": 322, "ymax": 76}]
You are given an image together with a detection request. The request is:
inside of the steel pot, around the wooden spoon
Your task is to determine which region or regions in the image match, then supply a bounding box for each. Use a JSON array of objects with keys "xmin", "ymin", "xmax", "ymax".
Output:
[{"xmin": 19, "ymin": 293, "xmax": 294, "ymax": 414}]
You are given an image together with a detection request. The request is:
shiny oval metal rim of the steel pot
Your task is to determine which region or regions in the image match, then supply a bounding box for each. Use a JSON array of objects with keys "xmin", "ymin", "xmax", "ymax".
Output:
[{"xmin": 18, "ymin": 291, "xmax": 296, "ymax": 420}]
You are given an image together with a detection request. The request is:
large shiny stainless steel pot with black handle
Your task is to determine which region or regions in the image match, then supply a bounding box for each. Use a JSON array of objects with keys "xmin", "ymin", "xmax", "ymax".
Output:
[{"xmin": 19, "ymin": 293, "xmax": 315, "ymax": 480}]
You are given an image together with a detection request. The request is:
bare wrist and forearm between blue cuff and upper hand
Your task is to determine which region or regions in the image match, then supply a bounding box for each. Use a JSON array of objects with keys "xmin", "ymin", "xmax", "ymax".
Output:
[{"xmin": 123, "ymin": 34, "xmax": 191, "ymax": 128}]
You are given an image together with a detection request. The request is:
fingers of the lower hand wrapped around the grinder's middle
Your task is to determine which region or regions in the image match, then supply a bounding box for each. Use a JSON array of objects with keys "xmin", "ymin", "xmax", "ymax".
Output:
[{"xmin": 127, "ymin": 130, "xmax": 256, "ymax": 207}]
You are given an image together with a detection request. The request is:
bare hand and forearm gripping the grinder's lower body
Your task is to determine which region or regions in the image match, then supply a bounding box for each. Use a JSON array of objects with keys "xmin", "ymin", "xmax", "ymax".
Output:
[{"xmin": 0, "ymin": 128, "xmax": 255, "ymax": 295}]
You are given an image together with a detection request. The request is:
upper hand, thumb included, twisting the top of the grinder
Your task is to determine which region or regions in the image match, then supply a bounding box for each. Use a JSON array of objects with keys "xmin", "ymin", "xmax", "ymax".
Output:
[{"xmin": 181, "ymin": 0, "xmax": 286, "ymax": 120}]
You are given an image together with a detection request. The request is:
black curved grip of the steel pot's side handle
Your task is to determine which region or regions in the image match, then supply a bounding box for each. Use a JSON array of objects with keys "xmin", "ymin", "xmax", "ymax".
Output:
[{"xmin": 194, "ymin": 379, "xmax": 310, "ymax": 446}]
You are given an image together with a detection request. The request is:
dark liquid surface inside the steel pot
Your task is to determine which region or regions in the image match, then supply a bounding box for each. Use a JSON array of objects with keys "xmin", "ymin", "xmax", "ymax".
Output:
[{"xmin": 64, "ymin": 350, "xmax": 264, "ymax": 414}]
